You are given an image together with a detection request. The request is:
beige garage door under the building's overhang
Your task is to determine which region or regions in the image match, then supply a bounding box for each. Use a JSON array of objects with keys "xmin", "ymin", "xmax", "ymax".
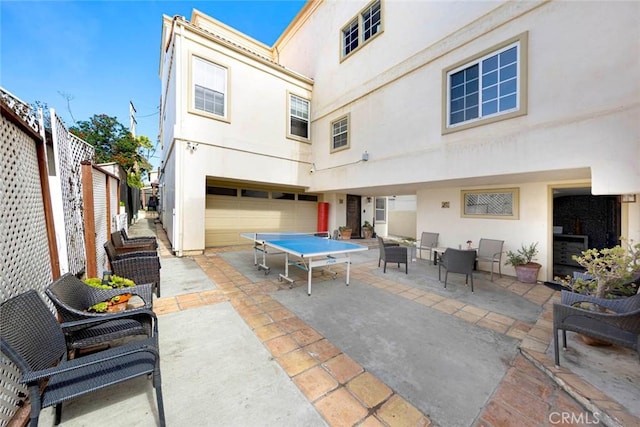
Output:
[{"xmin": 205, "ymin": 186, "xmax": 318, "ymax": 247}]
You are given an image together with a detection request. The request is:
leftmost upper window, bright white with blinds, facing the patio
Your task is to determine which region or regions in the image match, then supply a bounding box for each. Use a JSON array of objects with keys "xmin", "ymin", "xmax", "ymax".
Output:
[{"xmin": 192, "ymin": 56, "xmax": 227, "ymax": 117}]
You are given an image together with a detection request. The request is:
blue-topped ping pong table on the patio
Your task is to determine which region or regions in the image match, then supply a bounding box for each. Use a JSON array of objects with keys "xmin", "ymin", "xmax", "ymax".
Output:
[{"xmin": 241, "ymin": 233, "xmax": 369, "ymax": 295}]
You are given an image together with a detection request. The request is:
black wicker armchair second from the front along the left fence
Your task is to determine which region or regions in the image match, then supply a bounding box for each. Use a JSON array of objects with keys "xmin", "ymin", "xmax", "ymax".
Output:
[{"xmin": 45, "ymin": 273, "xmax": 153, "ymax": 355}]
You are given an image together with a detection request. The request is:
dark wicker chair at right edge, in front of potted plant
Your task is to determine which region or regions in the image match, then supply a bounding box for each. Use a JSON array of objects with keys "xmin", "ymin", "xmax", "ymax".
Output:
[{"xmin": 553, "ymin": 290, "xmax": 640, "ymax": 366}]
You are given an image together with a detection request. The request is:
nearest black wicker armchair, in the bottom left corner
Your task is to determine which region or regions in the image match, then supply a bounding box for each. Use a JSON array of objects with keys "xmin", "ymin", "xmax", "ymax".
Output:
[{"xmin": 0, "ymin": 290, "xmax": 165, "ymax": 427}]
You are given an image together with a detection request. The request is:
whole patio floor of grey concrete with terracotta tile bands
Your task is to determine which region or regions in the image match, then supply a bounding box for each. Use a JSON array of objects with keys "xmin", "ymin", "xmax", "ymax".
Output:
[{"xmin": 41, "ymin": 219, "xmax": 640, "ymax": 427}]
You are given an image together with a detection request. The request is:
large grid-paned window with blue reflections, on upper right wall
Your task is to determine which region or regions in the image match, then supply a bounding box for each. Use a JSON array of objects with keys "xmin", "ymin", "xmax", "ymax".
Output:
[{"xmin": 445, "ymin": 35, "xmax": 526, "ymax": 130}]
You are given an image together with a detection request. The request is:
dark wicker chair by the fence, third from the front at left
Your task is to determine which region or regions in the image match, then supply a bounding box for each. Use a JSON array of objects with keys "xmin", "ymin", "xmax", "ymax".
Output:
[{"xmin": 104, "ymin": 241, "xmax": 160, "ymax": 298}]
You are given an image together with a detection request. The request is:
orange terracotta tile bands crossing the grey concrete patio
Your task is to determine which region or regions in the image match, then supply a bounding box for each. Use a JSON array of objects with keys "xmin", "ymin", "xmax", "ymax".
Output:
[{"xmin": 144, "ymin": 226, "xmax": 640, "ymax": 427}]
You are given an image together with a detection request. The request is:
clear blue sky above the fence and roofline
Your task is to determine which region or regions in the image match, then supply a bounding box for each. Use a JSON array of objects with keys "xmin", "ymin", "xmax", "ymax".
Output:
[{"xmin": 0, "ymin": 0, "xmax": 305, "ymax": 166}]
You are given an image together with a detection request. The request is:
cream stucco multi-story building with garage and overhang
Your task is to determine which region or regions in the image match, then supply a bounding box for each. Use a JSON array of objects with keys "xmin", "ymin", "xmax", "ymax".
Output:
[{"xmin": 160, "ymin": 0, "xmax": 640, "ymax": 279}]
